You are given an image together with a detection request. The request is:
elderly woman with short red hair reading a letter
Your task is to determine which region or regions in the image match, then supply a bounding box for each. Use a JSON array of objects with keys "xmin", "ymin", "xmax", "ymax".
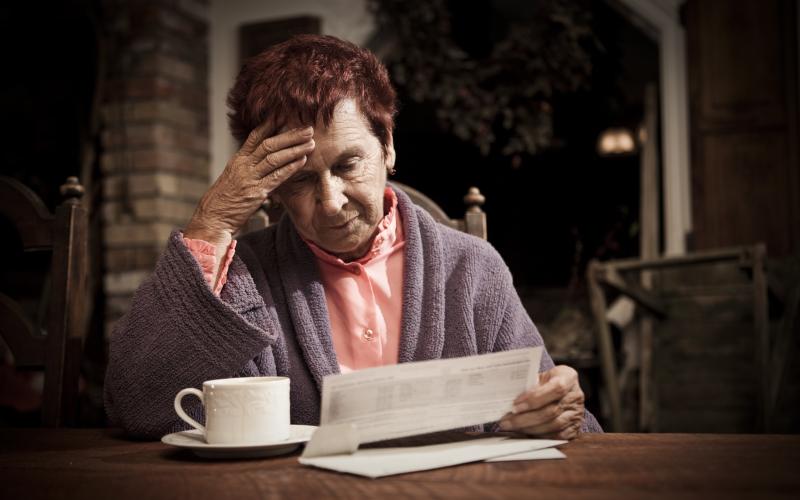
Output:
[{"xmin": 105, "ymin": 35, "xmax": 600, "ymax": 438}]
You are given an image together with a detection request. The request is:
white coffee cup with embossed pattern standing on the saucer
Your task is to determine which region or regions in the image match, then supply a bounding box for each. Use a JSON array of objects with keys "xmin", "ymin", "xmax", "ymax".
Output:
[{"xmin": 175, "ymin": 377, "xmax": 289, "ymax": 445}]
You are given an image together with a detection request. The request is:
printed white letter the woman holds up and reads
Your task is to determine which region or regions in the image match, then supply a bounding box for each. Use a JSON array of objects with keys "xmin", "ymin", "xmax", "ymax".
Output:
[{"xmin": 304, "ymin": 347, "xmax": 542, "ymax": 457}]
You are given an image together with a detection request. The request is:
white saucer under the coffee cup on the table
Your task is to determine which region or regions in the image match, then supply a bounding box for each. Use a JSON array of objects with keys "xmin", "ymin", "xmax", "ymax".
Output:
[{"xmin": 161, "ymin": 425, "xmax": 317, "ymax": 458}]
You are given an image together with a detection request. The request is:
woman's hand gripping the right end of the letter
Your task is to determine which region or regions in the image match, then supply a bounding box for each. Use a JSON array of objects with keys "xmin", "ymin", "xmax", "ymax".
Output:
[{"xmin": 500, "ymin": 365, "xmax": 584, "ymax": 439}]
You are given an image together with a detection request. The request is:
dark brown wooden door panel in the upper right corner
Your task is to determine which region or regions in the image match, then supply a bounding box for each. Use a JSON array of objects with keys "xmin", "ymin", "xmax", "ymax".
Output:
[{"xmin": 686, "ymin": 0, "xmax": 800, "ymax": 256}]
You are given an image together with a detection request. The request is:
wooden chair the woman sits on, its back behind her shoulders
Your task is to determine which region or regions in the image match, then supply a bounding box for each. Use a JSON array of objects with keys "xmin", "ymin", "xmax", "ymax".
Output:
[{"xmin": 242, "ymin": 182, "xmax": 487, "ymax": 240}]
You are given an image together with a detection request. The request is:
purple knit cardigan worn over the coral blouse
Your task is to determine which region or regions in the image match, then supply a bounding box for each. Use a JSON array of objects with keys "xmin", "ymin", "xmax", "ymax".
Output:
[{"xmin": 105, "ymin": 190, "xmax": 602, "ymax": 438}]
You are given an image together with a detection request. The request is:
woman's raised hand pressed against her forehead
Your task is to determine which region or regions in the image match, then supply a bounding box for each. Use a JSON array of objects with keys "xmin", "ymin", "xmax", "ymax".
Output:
[{"xmin": 184, "ymin": 122, "xmax": 314, "ymax": 247}]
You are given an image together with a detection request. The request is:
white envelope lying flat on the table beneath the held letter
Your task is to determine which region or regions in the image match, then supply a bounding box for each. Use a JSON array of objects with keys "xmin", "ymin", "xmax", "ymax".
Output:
[{"xmin": 300, "ymin": 437, "xmax": 564, "ymax": 478}]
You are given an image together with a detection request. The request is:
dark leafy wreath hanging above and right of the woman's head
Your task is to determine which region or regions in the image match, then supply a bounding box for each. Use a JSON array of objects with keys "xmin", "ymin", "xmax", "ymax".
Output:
[{"xmin": 370, "ymin": 0, "xmax": 596, "ymax": 156}]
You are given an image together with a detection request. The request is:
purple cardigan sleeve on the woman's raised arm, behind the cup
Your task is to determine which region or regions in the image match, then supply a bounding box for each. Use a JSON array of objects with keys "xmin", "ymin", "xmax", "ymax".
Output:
[{"xmin": 104, "ymin": 231, "xmax": 280, "ymax": 438}]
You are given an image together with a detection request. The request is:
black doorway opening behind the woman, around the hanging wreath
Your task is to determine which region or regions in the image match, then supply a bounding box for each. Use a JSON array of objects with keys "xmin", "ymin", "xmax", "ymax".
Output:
[{"xmin": 386, "ymin": 0, "xmax": 658, "ymax": 289}]
